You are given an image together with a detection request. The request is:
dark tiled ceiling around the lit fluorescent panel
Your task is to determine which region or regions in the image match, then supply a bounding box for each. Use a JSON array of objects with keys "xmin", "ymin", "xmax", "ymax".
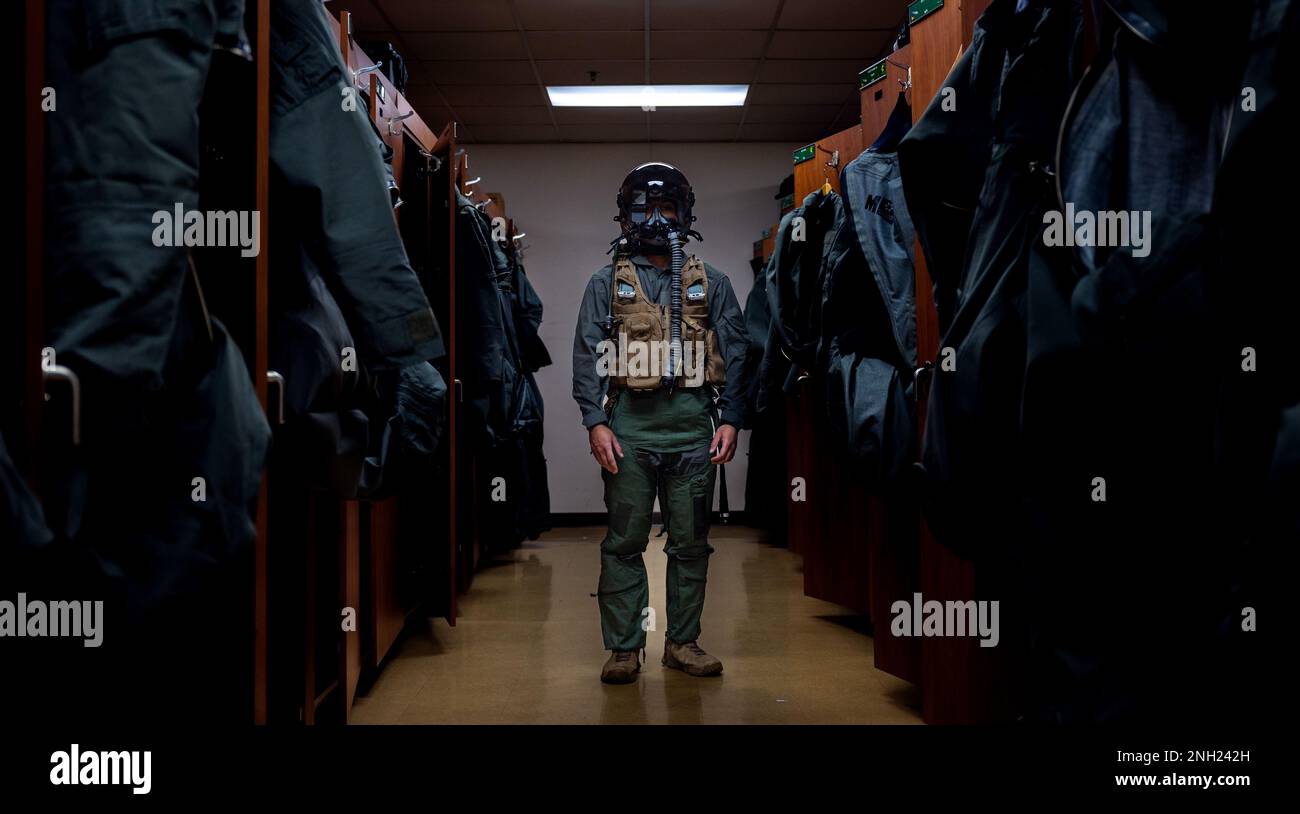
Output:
[{"xmin": 326, "ymin": 0, "xmax": 920, "ymax": 142}]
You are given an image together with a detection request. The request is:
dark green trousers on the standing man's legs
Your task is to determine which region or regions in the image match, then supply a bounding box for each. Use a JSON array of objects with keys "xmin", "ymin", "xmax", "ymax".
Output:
[{"xmin": 597, "ymin": 441, "xmax": 716, "ymax": 650}]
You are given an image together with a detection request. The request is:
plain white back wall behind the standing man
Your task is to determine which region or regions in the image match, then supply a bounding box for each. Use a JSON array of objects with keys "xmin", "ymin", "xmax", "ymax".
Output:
[{"xmin": 468, "ymin": 143, "xmax": 800, "ymax": 512}]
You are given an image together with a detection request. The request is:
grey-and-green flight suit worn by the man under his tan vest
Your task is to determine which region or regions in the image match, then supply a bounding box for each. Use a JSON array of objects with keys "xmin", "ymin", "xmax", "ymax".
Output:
[{"xmin": 573, "ymin": 250, "xmax": 749, "ymax": 650}]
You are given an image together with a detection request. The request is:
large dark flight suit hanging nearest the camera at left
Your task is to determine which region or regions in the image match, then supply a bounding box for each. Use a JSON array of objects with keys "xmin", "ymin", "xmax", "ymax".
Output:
[{"xmin": 39, "ymin": 0, "xmax": 270, "ymax": 718}]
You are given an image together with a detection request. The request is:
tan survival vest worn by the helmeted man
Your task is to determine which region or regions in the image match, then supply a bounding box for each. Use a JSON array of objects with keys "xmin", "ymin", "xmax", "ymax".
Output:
[{"xmin": 610, "ymin": 255, "xmax": 727, "ymax": 391}]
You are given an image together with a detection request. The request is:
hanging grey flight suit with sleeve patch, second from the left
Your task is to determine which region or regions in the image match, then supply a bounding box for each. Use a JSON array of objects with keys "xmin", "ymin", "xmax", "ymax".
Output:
[{"xmin": 270, "ymin": 0, "xmax": 446, "ymax": 499}]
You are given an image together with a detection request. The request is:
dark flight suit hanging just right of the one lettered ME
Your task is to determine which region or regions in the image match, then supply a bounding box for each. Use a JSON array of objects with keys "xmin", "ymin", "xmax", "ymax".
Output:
[{"xmin": 898, "ymin": 0, "xmax": 1083, "ymax": 559}]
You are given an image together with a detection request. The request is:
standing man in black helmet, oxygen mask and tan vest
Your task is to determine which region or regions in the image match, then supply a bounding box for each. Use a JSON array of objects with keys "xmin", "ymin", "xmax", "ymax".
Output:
[{"xmin": 573, "ymin": 163, "xmax": 749, "ymax": 684}]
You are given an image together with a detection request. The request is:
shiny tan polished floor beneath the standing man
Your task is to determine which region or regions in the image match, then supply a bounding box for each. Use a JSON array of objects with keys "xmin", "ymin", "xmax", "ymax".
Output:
[{"xmin": 352, "ymin": 527, "xmax": 920, "ymax": 724}]
